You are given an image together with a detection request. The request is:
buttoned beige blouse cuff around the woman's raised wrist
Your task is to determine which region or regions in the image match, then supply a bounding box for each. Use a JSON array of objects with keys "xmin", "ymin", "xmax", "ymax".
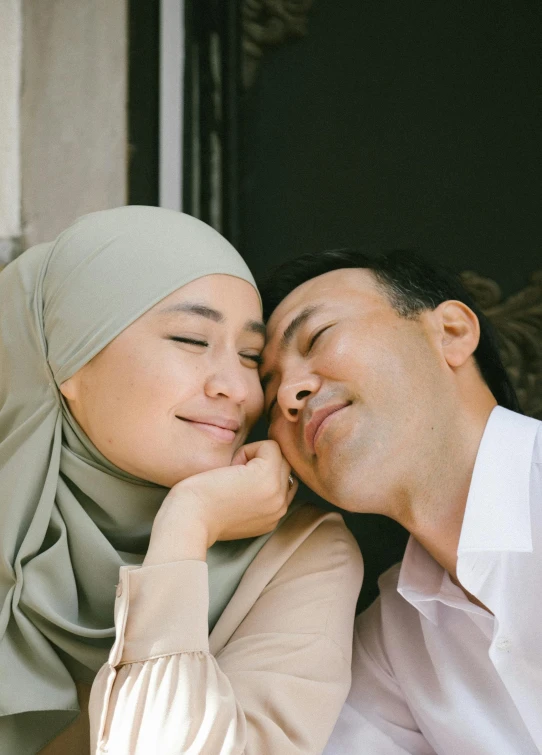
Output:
[{"xmin": 109, "ymin": 561, "xmax": 209, "ymax": 666}]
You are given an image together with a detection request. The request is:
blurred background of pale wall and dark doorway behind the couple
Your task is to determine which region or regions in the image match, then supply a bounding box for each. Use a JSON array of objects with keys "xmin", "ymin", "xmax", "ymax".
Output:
[{"xmin": 0, "ymin": 0, "xmax": 542, "ymax": 606}]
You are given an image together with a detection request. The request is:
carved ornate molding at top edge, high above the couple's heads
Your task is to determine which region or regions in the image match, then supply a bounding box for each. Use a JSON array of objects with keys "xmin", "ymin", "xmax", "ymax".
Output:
[{"xmin": 241, "ymin": 0, "xmax": 314, "ymax": 89}]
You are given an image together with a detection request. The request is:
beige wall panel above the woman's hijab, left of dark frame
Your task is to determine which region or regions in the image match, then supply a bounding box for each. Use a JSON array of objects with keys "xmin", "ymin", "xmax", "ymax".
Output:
[{"xmin": 21, "ymin": 0, "xmax": 128, "ymax": 246}]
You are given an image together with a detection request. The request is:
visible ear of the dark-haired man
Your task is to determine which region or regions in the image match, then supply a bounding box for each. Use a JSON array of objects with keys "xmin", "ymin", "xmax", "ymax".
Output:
[{"xmin": 434, "ymin": 299, "xmax": 480, "ymax": 367}]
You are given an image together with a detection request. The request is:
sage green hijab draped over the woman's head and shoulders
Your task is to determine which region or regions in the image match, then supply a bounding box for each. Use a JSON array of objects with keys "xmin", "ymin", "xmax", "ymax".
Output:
[{"xmin": 0, "ymin": 207, "xmax": 272, "ymax": 755}]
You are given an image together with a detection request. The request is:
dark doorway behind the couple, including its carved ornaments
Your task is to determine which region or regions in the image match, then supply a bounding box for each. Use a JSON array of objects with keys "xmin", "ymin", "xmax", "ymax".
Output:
[{"xmin": 180, "ymin": 0, "xmax": 542, "ymax": 607}]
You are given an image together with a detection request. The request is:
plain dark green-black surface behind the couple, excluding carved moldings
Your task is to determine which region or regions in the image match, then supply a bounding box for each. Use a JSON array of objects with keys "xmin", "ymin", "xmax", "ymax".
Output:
[{"xmin": 241, "ymin": 0, "xmax": 542, "ymax": 605}]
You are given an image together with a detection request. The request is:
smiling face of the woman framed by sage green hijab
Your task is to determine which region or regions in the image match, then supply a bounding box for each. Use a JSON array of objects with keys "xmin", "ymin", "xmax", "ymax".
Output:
[{"xmin": 60, "ymin": 275, "xmax": 265, "ymax": 487}]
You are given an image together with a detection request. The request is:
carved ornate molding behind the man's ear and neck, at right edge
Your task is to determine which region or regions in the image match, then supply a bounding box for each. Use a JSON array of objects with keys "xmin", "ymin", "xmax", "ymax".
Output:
[{"xmin": 461, "ymin": 270, "xmax": 542, "ymax": 419}]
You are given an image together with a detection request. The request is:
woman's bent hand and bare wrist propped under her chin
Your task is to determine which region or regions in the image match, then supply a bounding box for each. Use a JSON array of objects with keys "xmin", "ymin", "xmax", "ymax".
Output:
[{"xmin": 143, "ymin": 440, "xmax": 297, "ymax": 566}]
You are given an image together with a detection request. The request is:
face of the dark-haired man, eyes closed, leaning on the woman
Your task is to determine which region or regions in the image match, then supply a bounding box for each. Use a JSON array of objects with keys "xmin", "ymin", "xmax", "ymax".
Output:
[{"xmin": 261, "ymin": 269, "xmax": 444, "ymax": 513}]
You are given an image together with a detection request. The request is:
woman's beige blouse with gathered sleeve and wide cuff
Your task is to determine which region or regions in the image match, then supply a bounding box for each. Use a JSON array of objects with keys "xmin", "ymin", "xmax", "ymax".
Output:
[{"xmin": 89, "ymin": 514, "xmax": 363, "ymax": 755}]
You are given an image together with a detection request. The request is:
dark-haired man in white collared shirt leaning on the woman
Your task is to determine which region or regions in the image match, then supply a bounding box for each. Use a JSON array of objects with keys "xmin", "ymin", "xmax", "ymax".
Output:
[{"xmin": 262, "ymin": 252, "xmax": 542, "ymax": 755}]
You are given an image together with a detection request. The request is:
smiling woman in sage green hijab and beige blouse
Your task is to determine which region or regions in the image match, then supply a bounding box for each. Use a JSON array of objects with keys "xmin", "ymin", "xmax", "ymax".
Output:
[{"xmin": 0, "ymin": 207, "xmax": 361, "ymax": 755}]
